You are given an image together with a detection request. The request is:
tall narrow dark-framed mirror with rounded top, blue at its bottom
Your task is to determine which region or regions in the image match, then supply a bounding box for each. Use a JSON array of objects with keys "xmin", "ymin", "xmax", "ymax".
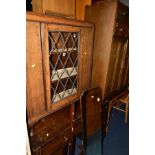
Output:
[{"xmin": 80, "ymin": 87, "xmax": 108, "ymax": 155}]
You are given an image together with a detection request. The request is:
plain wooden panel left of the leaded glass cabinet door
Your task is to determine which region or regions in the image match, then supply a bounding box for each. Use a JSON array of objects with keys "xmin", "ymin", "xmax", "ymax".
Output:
[{"xmin": 26, "ymin": 22, "xmax": 45, "ymax": 119}]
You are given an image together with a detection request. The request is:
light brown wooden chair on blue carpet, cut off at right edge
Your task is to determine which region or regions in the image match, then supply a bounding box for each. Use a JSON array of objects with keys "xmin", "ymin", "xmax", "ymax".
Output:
[{"xmin": 108, "ymin": 90, "xmax": 129, "ymax": 123}]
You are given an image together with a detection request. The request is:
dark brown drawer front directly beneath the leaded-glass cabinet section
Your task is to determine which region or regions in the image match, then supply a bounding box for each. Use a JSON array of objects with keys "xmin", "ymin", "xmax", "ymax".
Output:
[{"xmin": 30, "ymin": 106, "xmax": 71, "ymax": 148}]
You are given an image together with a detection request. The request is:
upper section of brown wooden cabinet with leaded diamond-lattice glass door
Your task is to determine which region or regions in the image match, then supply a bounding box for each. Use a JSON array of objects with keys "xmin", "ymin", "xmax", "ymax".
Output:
[{"xmin": 26, "ymin": 10, "xmax": 94, "ymax": 131}]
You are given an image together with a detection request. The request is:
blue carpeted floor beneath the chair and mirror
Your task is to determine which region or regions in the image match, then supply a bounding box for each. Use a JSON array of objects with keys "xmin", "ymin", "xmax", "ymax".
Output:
[{"xmin": 75, "ymin": 109, "xmax": 129, "ymax": 155}]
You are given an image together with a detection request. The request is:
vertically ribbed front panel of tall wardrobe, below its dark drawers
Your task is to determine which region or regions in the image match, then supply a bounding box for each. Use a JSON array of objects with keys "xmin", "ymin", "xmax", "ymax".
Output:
[{"xmin": 105, "ymin": 37, "xmax": 128, "ymax": 96}]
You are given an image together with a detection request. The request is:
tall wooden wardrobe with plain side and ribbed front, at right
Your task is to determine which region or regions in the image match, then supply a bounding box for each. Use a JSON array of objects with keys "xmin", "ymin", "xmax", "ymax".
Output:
[{"xmin": 85, "ymin": 0, "xmax": 129, "ymax": 99}]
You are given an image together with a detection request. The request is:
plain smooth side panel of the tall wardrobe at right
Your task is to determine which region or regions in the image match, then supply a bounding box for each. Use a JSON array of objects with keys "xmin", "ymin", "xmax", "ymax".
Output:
[{"xmin": 85, "ymin": 0, "xmax": 117, "ymax": 96}]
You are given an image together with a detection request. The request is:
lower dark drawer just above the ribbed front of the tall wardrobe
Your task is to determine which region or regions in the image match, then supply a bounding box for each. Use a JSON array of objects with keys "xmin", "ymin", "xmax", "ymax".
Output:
[{"xmin": 114, "ymin": 21, "xmax": 129, "ymax": 37}]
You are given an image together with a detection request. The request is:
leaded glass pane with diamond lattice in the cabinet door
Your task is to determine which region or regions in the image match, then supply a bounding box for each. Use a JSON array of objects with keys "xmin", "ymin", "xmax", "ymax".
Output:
[{"xmin": 48, "ymin": 31, "xmax": 79, "ymax": 103}]
